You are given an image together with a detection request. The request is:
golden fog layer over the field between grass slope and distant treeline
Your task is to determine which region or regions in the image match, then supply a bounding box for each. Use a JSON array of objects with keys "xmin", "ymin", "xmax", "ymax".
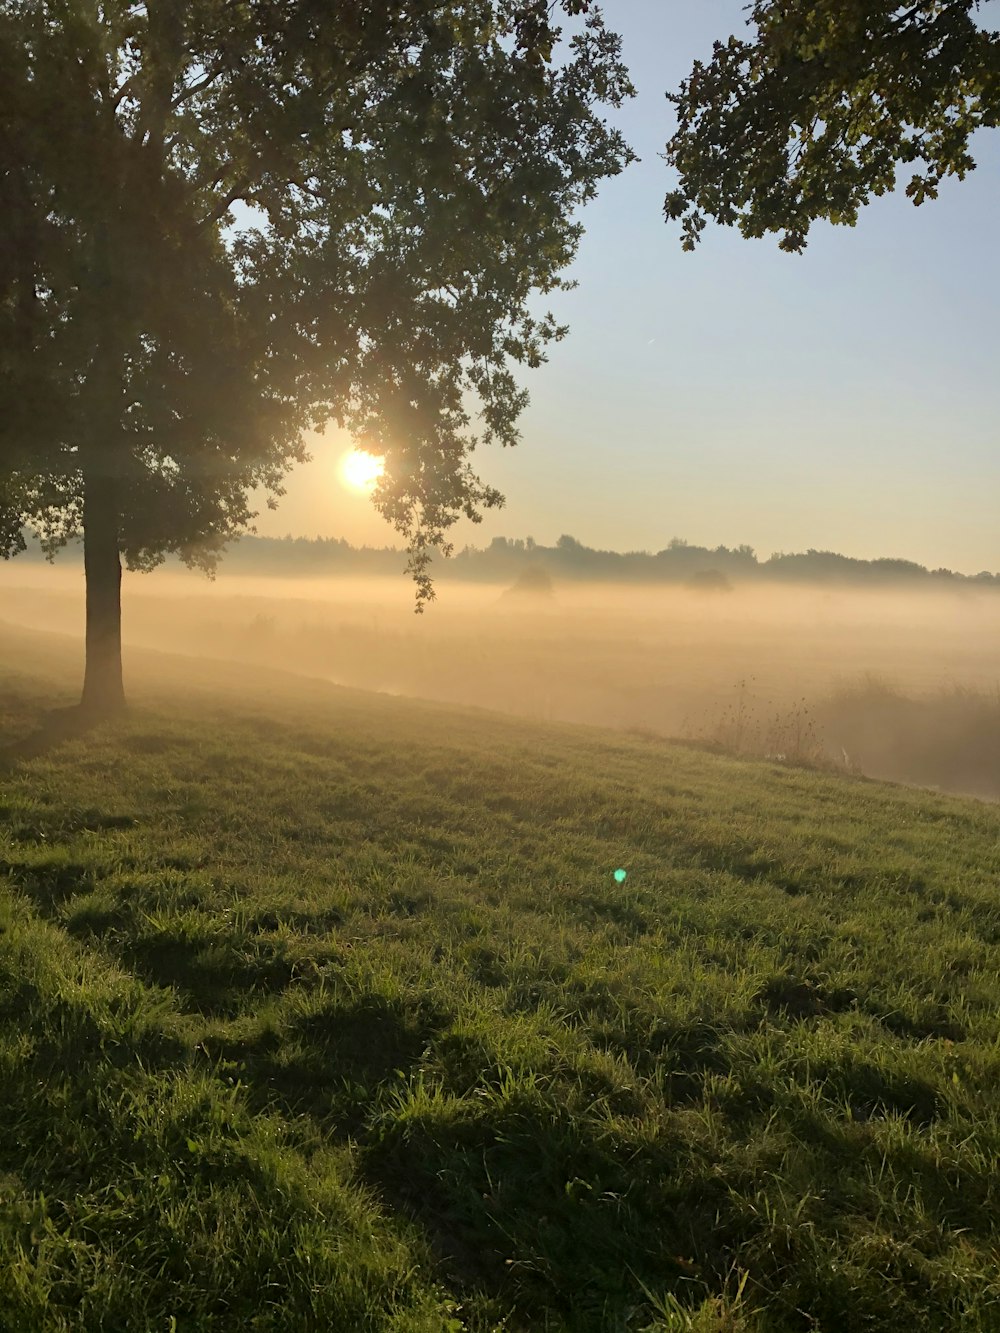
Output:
[{"xmin": 0, "ymin": 561, "xmax": 1000, "ymax": 798}]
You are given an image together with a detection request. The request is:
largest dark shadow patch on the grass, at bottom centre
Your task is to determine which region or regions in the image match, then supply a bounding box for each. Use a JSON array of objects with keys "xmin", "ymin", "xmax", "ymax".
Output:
[{"xmin": 361, "ymin": 1088, "xmax": 735, "ymax": 1333}]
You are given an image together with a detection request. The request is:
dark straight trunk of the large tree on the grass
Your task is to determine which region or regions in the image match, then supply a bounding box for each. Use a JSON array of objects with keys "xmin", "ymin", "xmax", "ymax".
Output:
[{"xmin": 80, "ymin": 463, "xmax": 125, "ymax": 717}]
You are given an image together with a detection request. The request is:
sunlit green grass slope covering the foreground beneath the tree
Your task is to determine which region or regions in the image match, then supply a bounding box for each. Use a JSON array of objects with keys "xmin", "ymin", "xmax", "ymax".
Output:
[{"xmin": 0, "ymin": 642, "xmax": 1000, "ymax": 1333}]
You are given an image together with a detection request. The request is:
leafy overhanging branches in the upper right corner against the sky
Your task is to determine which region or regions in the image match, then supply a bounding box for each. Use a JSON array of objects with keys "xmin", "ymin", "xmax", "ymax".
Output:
[{"xmin": 665, "ymin": 0, "xmax": 1000, "ymax": 252}]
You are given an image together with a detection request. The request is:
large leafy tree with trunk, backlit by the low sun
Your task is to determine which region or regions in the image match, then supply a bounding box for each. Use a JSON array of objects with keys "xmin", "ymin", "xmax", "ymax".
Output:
[{"xmin": 0, "ymin": 0, "xmax": 632, "ymax": 712}]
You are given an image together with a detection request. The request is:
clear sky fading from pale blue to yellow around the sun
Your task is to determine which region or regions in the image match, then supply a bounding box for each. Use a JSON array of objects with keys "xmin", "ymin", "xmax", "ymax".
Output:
[{"xmin": 257, "ymin": 0, "xmax": 1000, "ymax": 573}]
